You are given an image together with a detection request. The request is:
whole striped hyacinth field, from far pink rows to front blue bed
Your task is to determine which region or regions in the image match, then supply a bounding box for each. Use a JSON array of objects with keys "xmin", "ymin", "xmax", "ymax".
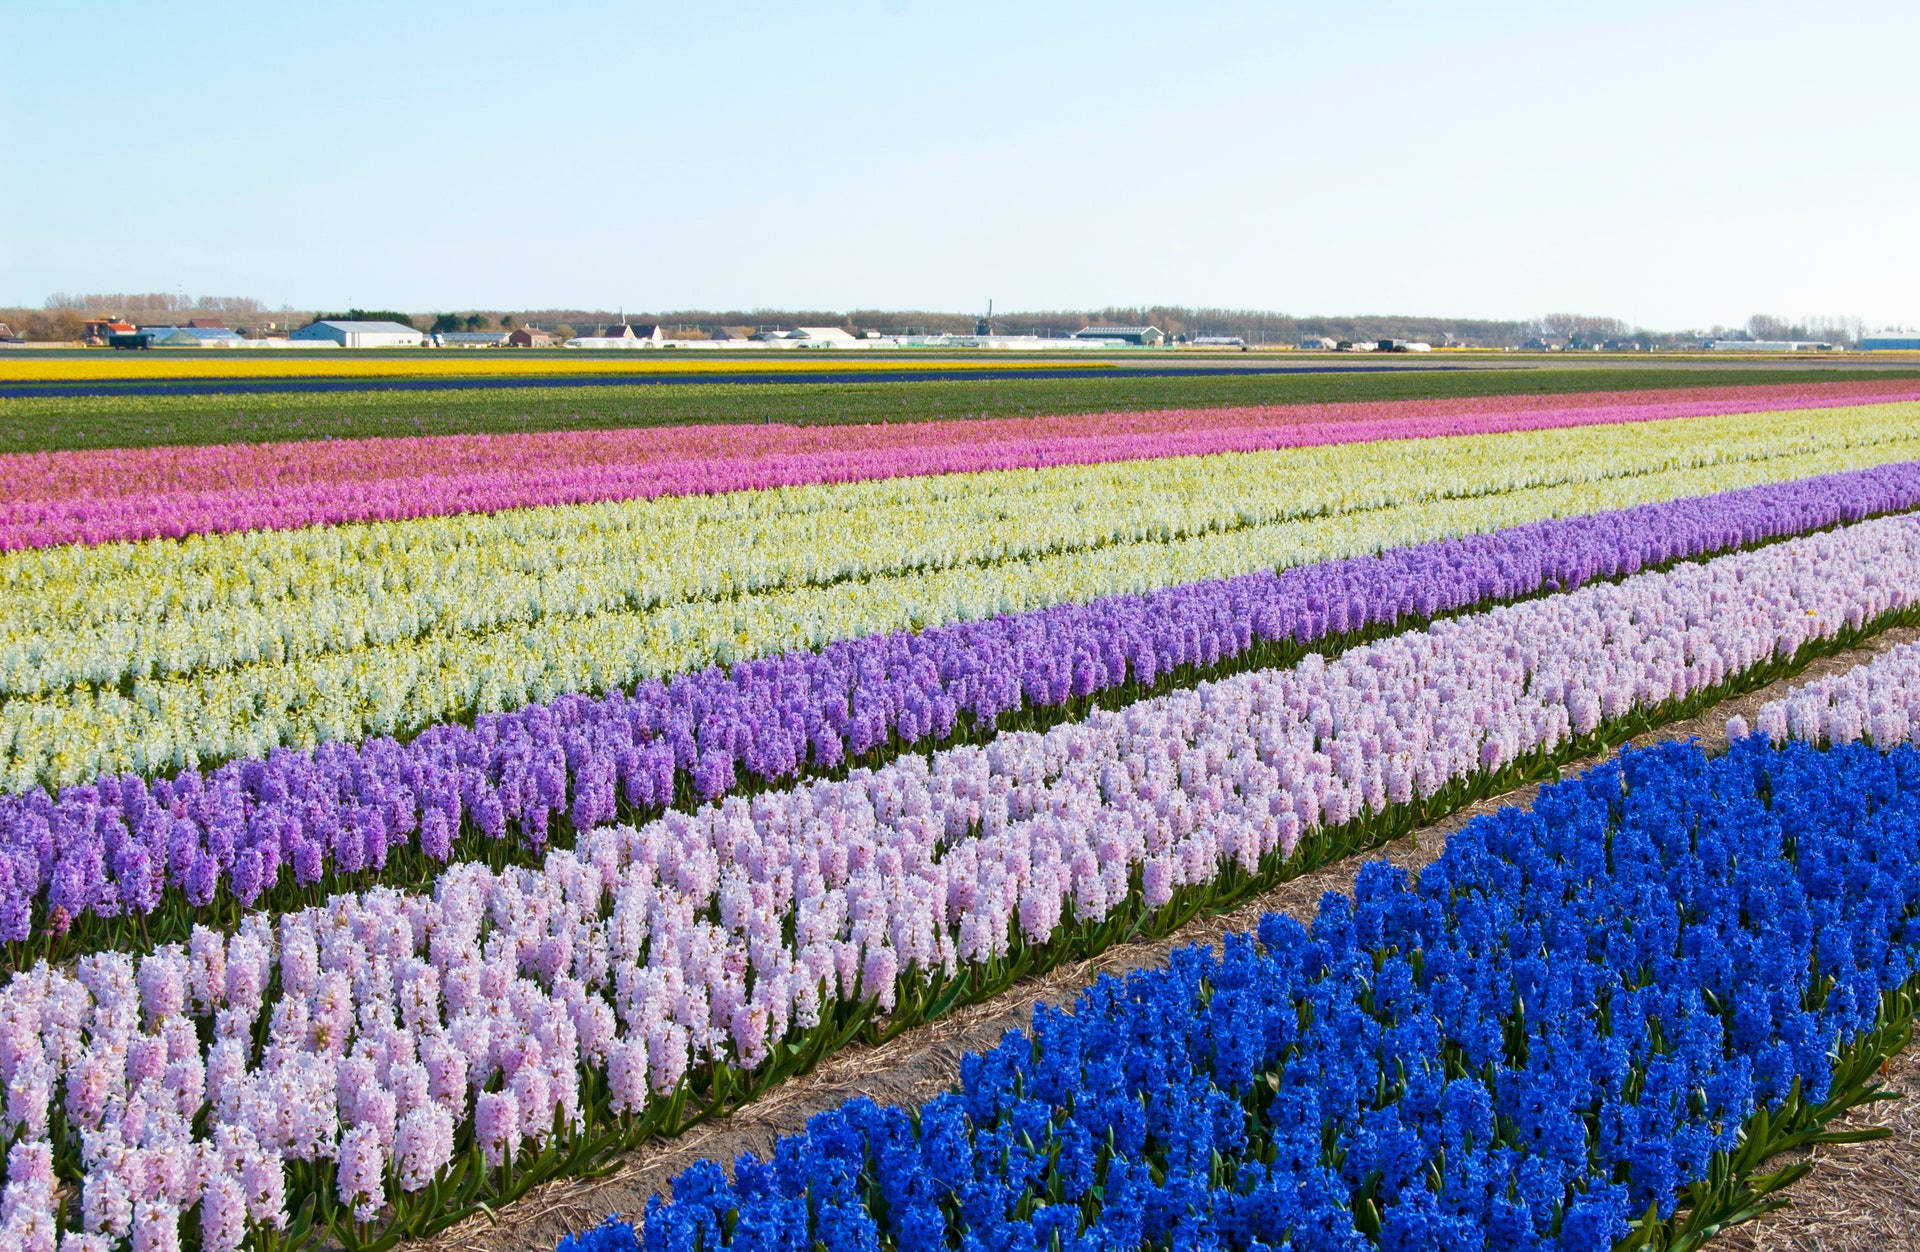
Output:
[{"xmin": 0, "ymin": 382, "xmax": 1920, "ymax": 1252}]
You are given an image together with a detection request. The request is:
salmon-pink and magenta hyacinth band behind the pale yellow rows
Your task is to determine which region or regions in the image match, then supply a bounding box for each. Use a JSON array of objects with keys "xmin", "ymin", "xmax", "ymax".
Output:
[{"xmin": 0, "ymin": 380, "xmax": 1920, "ymax": 549}]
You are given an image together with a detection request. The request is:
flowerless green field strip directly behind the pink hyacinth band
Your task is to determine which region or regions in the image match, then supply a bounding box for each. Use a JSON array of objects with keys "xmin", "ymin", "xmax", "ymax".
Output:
[{"xmin": 0, "ymin": 363, "xmax": 1920, "ymax": 453}]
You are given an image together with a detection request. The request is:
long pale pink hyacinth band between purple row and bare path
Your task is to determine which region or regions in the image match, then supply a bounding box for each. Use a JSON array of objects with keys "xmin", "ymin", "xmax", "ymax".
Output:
[{"xmin": 0, "ymin": 518, "xmax": 1920, "ymax": 1252}]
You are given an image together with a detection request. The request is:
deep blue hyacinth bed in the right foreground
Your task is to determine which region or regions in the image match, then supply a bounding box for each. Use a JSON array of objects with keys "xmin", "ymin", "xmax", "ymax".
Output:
[{"xmin": 561, "ymin": 739, "xmax": 1920, "ymax": 1252}]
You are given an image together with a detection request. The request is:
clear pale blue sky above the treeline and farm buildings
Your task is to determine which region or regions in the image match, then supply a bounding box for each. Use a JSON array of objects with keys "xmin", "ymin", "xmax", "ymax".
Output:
[{"xmin": 0, "ymin": 0, "xmax": 1920, "ymax": 328}]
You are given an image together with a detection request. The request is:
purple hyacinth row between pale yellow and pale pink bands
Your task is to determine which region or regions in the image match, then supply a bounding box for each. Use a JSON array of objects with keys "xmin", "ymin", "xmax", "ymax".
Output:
[{"xmin": 0, "ymin": 463, "xmax": 1920, "ymax": 941}]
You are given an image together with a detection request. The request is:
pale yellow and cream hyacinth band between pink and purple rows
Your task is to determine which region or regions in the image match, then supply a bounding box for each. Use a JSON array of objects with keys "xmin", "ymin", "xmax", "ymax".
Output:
[{"xmin": 0, "ymin": 403, "xmax": 1920, "ymax": 789}]
